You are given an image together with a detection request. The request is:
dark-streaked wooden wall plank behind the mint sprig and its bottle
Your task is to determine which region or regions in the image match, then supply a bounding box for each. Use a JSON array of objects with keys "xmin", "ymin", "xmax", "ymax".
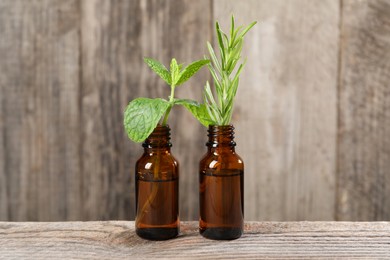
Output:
[{"xmin": 81, "ymin": 0, "xmax": 211, "ymax": 220}]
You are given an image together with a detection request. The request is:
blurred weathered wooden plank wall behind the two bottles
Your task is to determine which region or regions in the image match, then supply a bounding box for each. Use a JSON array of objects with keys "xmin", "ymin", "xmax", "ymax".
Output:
[{"xmin": 0, "ymin": 0, "xmax": 390, "ymax": 221}]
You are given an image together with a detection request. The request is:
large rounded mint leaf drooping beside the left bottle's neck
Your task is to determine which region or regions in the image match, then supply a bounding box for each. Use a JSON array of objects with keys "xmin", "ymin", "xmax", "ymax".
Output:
[{"xmin": 123, "ymin": 98, "xmax": 169, "ymax": 143}]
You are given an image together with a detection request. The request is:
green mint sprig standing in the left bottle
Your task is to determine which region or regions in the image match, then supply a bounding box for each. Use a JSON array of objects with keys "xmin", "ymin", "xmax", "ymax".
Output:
[{"xmin": 123, "ymin": 58, "xmax": 210, "ymax": 142}]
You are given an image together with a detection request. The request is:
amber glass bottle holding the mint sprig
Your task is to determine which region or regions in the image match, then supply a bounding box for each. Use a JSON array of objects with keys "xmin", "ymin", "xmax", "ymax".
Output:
[{"xmin": 135, "ymin": 125, "xmax": 180, "ymax": 240}]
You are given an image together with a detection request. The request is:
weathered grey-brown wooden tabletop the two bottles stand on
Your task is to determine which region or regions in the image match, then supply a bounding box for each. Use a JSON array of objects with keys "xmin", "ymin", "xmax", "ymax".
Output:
[{"xmin": 0, "ymin": 221, "xmax": 390, "ymax": 259}]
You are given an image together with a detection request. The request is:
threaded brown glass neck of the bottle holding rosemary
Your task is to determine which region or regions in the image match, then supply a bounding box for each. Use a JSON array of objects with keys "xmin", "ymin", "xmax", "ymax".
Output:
[{"xmin": 206, "ymin": 125, "xmax": 236, "ymax": 151}]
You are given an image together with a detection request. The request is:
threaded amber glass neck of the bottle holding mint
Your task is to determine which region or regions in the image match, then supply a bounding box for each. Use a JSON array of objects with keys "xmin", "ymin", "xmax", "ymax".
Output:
[{"xmin": 142, "ymin": 125, "xmax": 172, "ymax": 151}]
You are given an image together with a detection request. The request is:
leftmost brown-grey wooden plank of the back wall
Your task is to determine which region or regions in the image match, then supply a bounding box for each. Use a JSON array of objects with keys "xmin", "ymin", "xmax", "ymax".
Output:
[{"xmin": 0, "ymin": 0, "xmax": 81, "ymax": 220}]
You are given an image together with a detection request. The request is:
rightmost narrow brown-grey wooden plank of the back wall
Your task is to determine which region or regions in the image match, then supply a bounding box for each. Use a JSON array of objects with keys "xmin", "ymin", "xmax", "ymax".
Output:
[{"xmin": 337, "ymin": 0, "xmax": 390, "ymax": 220}]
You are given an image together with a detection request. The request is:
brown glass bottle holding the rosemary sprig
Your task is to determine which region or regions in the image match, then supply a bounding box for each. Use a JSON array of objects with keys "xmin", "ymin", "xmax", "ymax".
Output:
[{"xmin": 199, "ymin": 125, "xmax": 244, "ymax": 240}]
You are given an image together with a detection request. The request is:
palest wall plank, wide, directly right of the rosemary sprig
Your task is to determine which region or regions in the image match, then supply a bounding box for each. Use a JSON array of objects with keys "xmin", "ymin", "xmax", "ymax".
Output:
[{"xmin": 213, "ymin": 0, "xmax": 339, "ymax": 220}]
